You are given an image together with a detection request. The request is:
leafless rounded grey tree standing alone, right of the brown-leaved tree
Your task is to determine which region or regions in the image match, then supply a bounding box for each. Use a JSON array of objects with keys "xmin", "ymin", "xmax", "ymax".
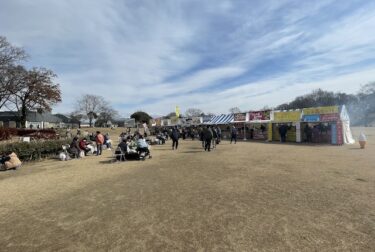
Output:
[{"xmin": 76, "ymin": 94, "xmax": 106, "ymax": 127}]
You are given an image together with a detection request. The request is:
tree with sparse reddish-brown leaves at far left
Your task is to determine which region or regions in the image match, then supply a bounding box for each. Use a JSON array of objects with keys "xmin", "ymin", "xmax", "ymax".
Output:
[{"xmin": 9, "ymin": 68, "xmax": 61, "ymax": 127}]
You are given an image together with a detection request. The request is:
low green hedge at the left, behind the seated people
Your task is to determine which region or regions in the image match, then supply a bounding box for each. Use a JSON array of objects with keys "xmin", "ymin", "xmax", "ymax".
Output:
[{"xmin": 0, "ymin": 139, "xmax": 72, "ymax": 161}]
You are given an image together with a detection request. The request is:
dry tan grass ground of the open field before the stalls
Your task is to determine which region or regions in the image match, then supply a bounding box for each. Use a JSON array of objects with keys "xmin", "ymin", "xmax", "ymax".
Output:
[{"xmin": 0, "ymin": 128, "xmax": 375, "ymax": 251}]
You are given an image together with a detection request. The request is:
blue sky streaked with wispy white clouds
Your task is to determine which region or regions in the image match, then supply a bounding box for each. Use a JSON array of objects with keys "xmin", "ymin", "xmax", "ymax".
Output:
[{"xmin": 0, "ymin": 0, "xmax": 375, "ymax": 116}]
